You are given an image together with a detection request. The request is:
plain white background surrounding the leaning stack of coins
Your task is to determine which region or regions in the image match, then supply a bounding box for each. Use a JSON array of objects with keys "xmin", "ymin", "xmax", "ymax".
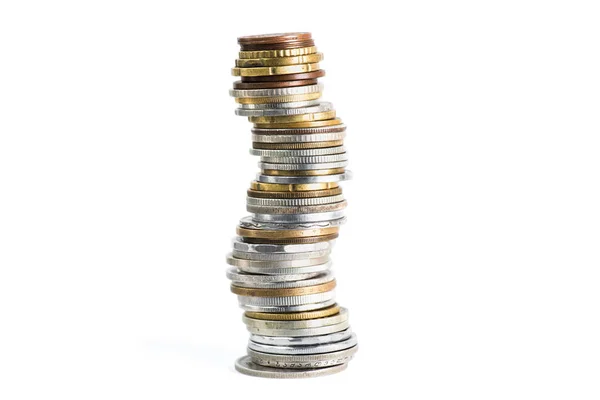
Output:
[{"xmin": 0, "ymin": 0, "xmax": 600, "ymax": 399}]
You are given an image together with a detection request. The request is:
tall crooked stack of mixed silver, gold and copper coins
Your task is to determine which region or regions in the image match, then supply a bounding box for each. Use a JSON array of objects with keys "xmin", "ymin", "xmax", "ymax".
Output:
[{"xmin": 227, "ymin": 33, "xmax": 358, "ymax": 378}]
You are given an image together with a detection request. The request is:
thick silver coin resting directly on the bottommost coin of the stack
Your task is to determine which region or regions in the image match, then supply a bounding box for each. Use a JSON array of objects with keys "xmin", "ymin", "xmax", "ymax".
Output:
[{"xmin": 248, "ymin": 346, "xmax": 358, "ymax": 369}]
